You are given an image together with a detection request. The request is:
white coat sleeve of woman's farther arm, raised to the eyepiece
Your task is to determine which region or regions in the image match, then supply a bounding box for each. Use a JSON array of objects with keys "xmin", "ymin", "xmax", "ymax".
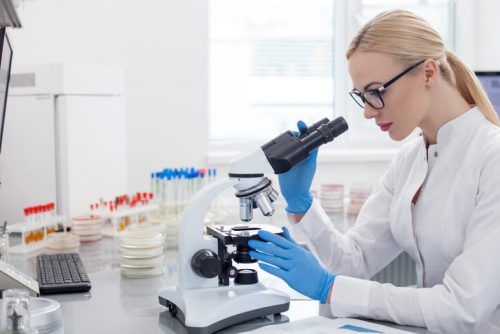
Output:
[{"xmin": 292, "ymin": 156, "xmax": 401, "ymax": 278}]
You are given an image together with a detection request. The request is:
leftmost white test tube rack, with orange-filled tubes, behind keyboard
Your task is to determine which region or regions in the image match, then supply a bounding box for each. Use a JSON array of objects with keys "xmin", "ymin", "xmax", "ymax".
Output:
[{"xmin": 7, "ymin": 216, "xmax": 67, "ymax": 254}]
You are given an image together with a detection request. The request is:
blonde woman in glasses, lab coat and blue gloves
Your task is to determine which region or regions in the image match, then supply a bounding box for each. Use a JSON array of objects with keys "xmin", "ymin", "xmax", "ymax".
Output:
[{"xmin": 250, "ymin": 10, "xmax": 500, "ymax": 333}]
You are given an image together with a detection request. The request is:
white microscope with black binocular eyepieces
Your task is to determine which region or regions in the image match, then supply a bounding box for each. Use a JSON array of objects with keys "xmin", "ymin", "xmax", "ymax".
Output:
[{"xmin": 158, "ymin": 117, "xmax": 348, "ymax": 333}]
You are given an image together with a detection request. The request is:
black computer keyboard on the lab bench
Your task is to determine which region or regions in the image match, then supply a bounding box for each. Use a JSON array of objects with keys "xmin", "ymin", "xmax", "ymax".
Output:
[{"xmin": 36, "ymin": 253, "xmax": 92, "ymax": 294}]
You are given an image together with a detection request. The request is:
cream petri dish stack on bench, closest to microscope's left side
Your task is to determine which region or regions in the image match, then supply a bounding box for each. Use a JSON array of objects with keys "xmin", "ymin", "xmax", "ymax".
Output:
[{"xmin": 117, "ymin": 229, "xmax": 165, "ymax": 278}]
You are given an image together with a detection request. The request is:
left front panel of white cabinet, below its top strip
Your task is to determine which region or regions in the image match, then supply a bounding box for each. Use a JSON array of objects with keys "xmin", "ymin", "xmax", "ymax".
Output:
[{"xmin": 0, "ymin": 95, "xmax": 56, "ymax": 223}]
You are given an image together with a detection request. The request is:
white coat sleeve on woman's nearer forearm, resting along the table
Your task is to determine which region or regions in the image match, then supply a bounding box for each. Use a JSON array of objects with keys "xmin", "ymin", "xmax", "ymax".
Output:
[{"xmin": 330, "ymin": 142, "xmax": 500, "ymax": 333}]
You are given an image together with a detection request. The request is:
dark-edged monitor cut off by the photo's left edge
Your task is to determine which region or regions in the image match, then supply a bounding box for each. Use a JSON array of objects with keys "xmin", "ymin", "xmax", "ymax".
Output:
[{"xmin": 0, "ymin": 28, "xmax": 12, "ymax": 153}]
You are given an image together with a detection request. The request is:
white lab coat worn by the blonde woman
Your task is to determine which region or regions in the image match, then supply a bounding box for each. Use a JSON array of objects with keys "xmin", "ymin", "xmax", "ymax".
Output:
[{"xmin": 292, "ymin": 108, "xmax": 500, "ymax": 334}]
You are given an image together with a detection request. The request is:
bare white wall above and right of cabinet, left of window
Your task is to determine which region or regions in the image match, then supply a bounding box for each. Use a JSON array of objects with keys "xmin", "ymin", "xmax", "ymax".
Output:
[{"xmin": 10, "ymin": 0, "xmax": 208, "ymax": 191}]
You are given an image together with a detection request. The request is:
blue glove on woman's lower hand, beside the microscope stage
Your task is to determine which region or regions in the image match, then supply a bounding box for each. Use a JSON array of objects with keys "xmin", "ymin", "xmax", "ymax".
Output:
[{"xmin": 248, "ymin": 227, "xmax": 336, "ymax": 304}]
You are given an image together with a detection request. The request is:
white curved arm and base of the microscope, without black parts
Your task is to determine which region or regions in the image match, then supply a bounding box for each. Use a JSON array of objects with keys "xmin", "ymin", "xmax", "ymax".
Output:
[{"xmin": 159, "ymin": 150, "xmax": 290, "ymax": 333}]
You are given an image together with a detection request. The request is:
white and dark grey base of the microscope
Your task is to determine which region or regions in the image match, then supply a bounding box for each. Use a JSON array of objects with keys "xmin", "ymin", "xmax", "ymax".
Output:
[{"xmin": 158, "ymin": 283, "xmax": 290, "ymax": 334}]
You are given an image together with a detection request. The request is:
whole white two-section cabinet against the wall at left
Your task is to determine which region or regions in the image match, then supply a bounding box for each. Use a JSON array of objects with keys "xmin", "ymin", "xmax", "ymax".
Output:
[{"xmin": 0, "ymin": 64, "xmax": 128, "ymax": 223}]
